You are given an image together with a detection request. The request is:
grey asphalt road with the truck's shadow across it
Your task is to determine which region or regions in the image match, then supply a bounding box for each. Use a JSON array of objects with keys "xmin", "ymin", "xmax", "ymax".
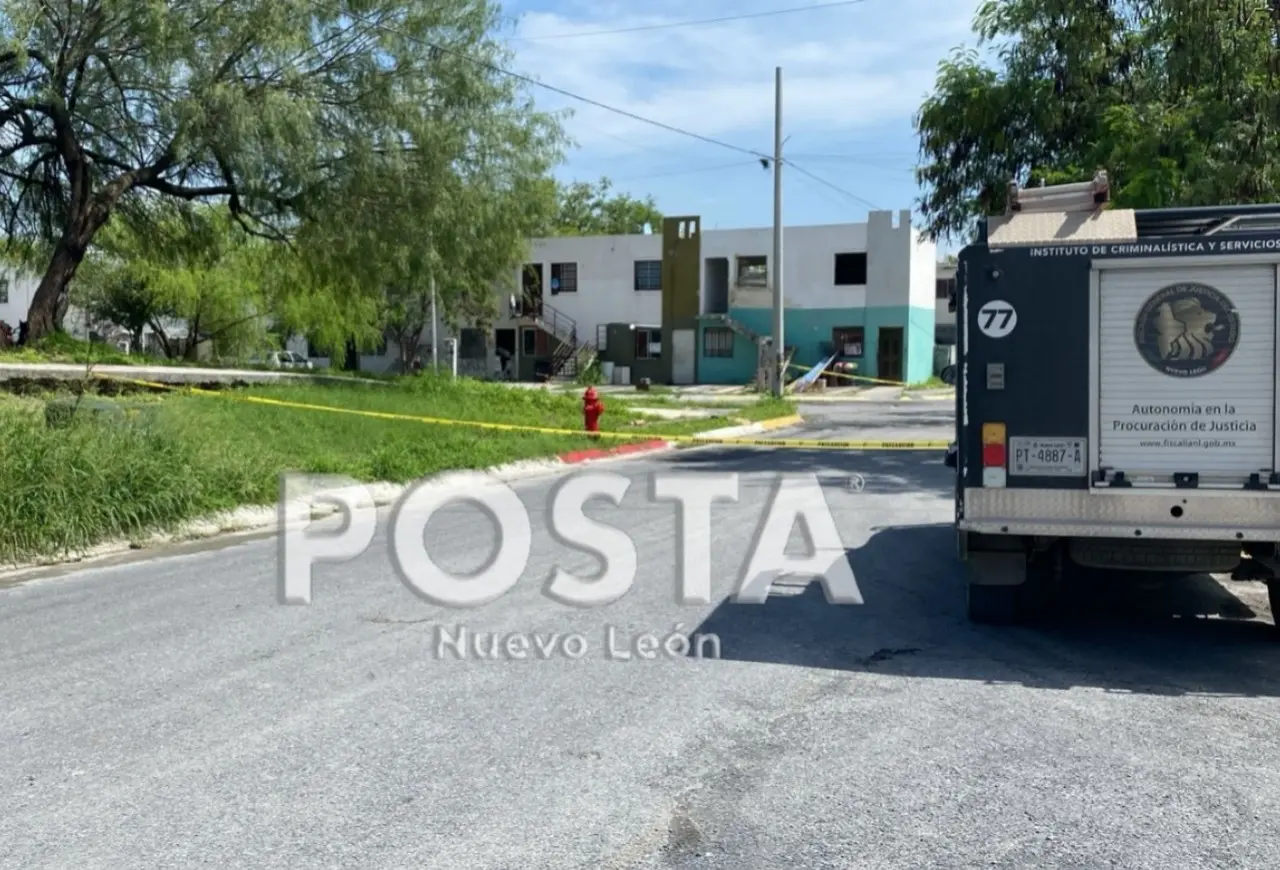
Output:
[{"xmin": 0, "ymin": 403, "xmax": 1280, "ymax": 870}]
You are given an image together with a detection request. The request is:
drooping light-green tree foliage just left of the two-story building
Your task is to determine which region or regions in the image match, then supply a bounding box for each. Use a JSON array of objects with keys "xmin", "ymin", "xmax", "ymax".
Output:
[{"xmin": 293, "ymin": 105, "xmax": 563, "ymax": 365}]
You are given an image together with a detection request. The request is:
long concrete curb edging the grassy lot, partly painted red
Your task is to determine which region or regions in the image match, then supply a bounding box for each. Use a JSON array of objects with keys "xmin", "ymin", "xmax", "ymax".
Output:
[{"xmin": 0, "ymin": 416, "xmax": 803, "ymax": 580}]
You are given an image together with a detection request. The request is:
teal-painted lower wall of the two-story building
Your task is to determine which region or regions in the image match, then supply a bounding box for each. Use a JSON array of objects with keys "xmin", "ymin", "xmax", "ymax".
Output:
[{"xmin": 698, "ymin": 306, "xmax": 934, "ymax": 384}]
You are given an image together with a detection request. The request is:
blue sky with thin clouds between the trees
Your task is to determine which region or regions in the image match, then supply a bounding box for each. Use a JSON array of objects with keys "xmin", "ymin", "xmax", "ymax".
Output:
[{"xmin": 504, "ymin": 0, "xmax": 978, "ymax": 249}]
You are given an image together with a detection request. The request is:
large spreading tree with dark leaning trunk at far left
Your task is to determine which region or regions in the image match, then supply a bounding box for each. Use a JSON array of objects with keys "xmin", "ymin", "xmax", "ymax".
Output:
[{"xmin": 0, "ymin": 0, "xmax": 553, "ymax": 340}]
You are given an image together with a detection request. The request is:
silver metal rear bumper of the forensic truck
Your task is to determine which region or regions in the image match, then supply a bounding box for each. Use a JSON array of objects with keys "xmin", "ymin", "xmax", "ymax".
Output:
[{"xmin": 956, "ymin": 487, "xmax": 1280, "ymax": 542}]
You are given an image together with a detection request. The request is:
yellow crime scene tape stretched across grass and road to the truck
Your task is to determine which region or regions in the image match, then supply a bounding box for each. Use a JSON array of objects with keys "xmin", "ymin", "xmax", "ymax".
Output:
[{"xmin": 93, "ymin": 372, "xmax": 948, "ymax": 450}]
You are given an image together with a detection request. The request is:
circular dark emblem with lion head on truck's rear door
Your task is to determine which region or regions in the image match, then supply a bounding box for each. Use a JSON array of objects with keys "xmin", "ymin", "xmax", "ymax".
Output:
[{"xmin": 1133, "ymin": 281, "xmax": 1240, "ymax": 377}]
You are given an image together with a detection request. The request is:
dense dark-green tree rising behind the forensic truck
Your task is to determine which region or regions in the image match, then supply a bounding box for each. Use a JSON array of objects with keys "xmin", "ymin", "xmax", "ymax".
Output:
[{"xmin": 915, "ymin": 0, "xmax": 1280, "ymax": 238}]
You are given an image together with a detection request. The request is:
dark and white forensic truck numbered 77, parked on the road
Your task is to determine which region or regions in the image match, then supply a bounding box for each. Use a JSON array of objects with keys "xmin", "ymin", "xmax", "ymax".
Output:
[{"xmin": 947, "ymin": 173, "xmax": 1280, "ymax": 622}]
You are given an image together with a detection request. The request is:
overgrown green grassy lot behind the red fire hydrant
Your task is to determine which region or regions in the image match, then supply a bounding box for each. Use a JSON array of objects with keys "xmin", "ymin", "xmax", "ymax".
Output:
[{"xmin": 0, "ymin": 375, "xmax": 794, "ymax": 563}]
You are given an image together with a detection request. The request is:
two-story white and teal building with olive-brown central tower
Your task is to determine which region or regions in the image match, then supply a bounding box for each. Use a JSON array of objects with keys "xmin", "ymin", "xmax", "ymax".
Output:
[{"xmin": 483, "ymin": 211, "xmax": 937, "ymax": 384}]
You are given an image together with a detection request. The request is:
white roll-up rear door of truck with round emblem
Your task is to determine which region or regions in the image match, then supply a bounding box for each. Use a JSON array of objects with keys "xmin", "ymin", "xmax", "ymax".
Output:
[{"xmin": 1091, "ymin": 260, "xmax": 1280, "ymax": 490}]
